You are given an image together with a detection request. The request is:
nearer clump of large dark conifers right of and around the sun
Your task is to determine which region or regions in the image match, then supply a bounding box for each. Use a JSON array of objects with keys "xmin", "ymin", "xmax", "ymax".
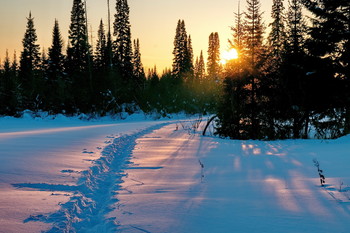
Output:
[{"xmin": 217, "ymin": 0, "xmax": 350, "ymax": 139}]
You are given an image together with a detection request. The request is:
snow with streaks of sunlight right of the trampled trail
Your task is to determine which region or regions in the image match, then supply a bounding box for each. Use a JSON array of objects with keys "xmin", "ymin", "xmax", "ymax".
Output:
[{"xmin": 109, "ymin": 125, "xmax": 350, "ymax": 233}]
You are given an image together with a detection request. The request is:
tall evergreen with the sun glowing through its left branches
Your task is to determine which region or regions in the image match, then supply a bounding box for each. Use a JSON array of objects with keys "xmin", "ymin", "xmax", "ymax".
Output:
[{"xmin": 218, "ymin": 0, "xmax": 269, "ymax": 139}]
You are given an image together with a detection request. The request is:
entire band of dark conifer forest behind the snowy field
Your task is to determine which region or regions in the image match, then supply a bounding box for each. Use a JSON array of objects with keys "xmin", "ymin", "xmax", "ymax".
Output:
[{"xmin": 0, "ymin": 0, "xmax": 350, "ymax": 140}]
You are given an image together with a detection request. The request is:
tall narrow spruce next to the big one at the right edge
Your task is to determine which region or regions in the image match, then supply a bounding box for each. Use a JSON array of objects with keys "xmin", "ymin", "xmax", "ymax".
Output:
[{"xmin": 280, "ymin": 0, "xmax": 313, "ymax": 138}]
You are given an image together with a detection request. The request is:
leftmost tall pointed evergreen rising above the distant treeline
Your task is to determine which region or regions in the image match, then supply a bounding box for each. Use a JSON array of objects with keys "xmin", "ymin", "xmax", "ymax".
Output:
[{"xmin": 19, "ymin": 13, "xmax": 40, "ymax": 108}]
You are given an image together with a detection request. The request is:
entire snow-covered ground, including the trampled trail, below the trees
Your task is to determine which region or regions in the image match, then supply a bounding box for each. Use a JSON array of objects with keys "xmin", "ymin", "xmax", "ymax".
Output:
[{"xmin": 0, "ymin": 115, "xmax": 350, "ymax": 233}]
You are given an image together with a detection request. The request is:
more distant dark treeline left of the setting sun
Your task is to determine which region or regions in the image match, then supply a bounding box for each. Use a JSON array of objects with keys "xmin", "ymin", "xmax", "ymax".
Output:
[{"xmin": 0, "ymin": 0, "xmax": 219, "ymax": 116}]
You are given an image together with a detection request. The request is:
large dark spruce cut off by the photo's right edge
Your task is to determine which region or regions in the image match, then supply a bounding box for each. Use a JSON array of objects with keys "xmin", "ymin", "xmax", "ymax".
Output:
[{"xmin": 302, "ymin": 0, "xmax": 350, "ymax": 136}]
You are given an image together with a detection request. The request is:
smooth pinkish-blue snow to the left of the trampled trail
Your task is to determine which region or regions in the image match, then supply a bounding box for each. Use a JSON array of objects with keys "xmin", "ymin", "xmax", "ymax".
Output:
[{"xmin": 0, "ymin": 117, "xmax": 171, "ymax": 233}]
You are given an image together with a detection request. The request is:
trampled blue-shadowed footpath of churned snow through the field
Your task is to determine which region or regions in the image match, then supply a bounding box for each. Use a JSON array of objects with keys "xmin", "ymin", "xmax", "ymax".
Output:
[{"xmin": 14, "ymin": 124, "xmax": 171, "ymax": 232}]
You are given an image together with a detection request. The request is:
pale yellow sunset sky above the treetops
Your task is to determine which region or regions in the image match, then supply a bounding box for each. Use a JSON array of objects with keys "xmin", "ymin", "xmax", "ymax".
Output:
[{"xmin": 0, "ymin": 0, "xmax": 272, "ymax": 72}]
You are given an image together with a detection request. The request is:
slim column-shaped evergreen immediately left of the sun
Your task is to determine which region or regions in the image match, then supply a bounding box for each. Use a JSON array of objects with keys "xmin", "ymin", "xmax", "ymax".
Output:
[{"xmin": 207, "ymin": 32, "xmax": 221, "ymax": 79}]
